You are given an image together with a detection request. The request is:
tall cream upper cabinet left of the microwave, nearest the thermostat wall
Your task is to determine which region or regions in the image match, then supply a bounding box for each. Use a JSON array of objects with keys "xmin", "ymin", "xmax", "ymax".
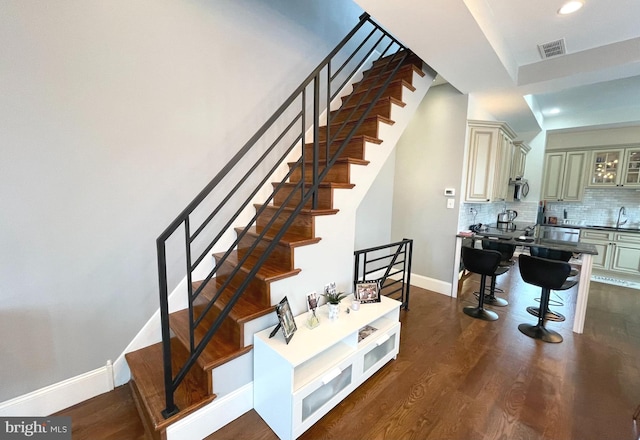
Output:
[{"xmin": 465, "ymin": 121, "xmax": 515, "ymax": 203}]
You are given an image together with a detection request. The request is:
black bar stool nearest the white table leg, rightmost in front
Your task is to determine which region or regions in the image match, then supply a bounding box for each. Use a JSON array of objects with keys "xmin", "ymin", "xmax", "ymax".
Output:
[{"xmin": 518, "ymin": 254, "xmax": 571, "ymax": 343}]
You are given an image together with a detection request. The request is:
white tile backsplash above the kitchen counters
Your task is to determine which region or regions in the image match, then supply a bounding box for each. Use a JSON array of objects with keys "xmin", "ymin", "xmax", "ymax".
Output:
[{"xmin": 458, "ymin": 188, "xmax": 640, "ymax": 230}]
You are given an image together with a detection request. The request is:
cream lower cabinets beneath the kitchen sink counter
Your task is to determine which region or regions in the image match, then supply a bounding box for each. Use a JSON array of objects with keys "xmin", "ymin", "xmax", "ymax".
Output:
[{"xmin": 580, "ymin": 229, "xmax": 640, "ymax": 275}]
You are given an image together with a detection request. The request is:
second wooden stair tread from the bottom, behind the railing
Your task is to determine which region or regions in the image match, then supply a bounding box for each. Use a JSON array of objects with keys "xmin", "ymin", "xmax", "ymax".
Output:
[{"xmin": 171, "ymin": 310, "xmax": 255, "ymax": 371}]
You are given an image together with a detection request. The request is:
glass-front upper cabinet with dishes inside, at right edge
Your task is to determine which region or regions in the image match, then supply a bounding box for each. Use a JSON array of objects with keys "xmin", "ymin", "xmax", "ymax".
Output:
[{"xmin": 588, "ymin": 147, "xmax": 640, "ymax": 188}]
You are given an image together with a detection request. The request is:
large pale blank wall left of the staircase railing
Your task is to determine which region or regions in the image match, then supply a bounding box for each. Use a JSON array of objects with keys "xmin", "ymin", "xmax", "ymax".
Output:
[{"xmin": 0, "ymin": 0, "xmax": 361, "ymax": 401}]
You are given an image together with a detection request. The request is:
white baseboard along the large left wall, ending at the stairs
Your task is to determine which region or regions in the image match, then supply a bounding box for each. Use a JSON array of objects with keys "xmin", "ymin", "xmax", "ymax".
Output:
[{"xmin": 0, "ymin": 361, "xmax": 114, "ymax": 417}]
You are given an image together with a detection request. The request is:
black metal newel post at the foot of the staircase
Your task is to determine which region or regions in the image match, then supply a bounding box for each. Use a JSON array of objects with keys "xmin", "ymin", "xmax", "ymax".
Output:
[{"xmin": 156, "ymin": 237, "xmax": 178, "ymax": 419}]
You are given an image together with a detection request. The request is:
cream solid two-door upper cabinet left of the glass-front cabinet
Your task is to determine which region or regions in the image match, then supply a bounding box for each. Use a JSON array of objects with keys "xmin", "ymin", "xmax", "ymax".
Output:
[{"xmin": 542, "ymin": 151, "xmax": 589, "ymax": 202}]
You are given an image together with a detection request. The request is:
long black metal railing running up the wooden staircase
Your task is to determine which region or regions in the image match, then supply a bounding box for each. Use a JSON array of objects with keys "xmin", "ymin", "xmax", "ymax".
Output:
[{"xmin": 156, "ymin": 14, "xmax": 407, "ymax": 418}]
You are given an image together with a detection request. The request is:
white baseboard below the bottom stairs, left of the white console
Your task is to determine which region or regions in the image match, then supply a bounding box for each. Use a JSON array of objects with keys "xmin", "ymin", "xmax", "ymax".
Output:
[{"xmin": 167, "ymin": 382, "xmax": 253, "ymax": 440}]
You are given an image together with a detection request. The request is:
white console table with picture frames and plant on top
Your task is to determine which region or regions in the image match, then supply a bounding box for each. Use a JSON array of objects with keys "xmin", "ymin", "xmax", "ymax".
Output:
[{"xmin": 253, "ymin": 296, "xmax": 401, "ymax": 440}]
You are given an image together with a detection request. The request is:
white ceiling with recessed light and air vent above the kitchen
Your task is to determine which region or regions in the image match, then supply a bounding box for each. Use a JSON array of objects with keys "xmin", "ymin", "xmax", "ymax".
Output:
[{"xmin": 356, "ymin": 0, "xmax": 640, "ymax": 133}]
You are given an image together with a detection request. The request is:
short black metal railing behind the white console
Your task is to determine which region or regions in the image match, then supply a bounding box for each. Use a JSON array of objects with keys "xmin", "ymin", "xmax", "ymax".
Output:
[{"xmin": 353, "ymin": 238, "xmax": 413, "ymax": 310}]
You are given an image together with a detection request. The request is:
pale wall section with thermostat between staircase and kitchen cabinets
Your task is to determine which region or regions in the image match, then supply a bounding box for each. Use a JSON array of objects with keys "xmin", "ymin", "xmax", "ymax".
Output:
[{"xmin": 392, "ymin": 84, "xmax": 468, "ymax": 282}]
